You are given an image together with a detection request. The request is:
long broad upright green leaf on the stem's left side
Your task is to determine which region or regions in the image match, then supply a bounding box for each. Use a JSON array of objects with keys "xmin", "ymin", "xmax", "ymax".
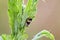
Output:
[{"xmin": 8, "ymin": 0, "xmax": 22, "ymax": 36}]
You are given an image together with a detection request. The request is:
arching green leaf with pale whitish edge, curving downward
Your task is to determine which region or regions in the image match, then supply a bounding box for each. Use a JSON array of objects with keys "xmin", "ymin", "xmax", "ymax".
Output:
[{"xmin": 32, "ymin": 30, "xmax": 55, "ymax": 40}]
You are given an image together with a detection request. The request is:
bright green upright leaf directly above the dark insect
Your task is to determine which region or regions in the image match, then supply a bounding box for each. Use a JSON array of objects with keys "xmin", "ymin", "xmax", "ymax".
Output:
[{"xmin": 25, "ymin": 0, "xmax": 37, "ymax": 18}]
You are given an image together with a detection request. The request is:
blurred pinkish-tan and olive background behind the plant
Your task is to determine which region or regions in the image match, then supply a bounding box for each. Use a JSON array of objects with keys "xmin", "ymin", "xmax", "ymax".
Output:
[{"xmin": 0, "ymin": 0, "xmax": 60, "ymax": 40}]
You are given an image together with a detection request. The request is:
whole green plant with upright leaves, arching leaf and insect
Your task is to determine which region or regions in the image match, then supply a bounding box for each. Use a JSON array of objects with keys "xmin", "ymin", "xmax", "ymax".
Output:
[{"xmin": 0, "ymin": 0, "xmax": 55, "ymax": 40}]
